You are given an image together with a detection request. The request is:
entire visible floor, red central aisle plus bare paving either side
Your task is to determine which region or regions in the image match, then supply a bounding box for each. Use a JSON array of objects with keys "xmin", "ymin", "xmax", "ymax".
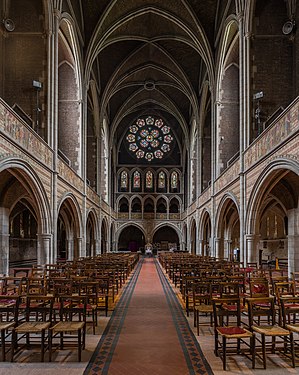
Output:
[{"xmin": 0, "ymin": 257, "xmax": 299, "ymax": 375}]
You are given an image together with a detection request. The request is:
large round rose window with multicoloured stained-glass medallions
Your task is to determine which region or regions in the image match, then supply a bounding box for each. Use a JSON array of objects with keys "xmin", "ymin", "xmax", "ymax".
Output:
[{"xmin": 126, "ymin": 116, "xmax": 174, "ymax": 161}]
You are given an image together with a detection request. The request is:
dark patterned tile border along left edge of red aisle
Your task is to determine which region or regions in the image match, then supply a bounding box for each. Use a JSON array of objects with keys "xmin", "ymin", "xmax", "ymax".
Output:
[{"xmin": 84, "ymin": 260, "xmax": 143, "ymax": 375}]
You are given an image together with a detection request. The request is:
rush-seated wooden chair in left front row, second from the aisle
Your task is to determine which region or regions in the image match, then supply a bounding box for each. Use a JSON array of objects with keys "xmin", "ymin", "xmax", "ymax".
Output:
[{"xmin": 11, "ymin": 295, "xmax": 54, "ymax": 362}]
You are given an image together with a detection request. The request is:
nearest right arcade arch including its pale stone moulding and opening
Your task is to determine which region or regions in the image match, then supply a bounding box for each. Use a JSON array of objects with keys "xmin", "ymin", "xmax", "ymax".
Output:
[{"xmin": 246, "ymin": 160, "xmax": 299, "ymax": 273}]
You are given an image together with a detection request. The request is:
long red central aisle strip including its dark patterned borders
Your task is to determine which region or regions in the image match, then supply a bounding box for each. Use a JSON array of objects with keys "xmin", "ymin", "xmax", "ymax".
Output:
[{"xmin": 84, "ymin": 258, "xmax": 213, "ymax": 375}]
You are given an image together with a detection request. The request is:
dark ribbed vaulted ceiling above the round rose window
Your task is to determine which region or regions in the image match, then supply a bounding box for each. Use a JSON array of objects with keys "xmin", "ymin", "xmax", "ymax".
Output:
[{"xmin": 64, "ymin": 0, "xmax": 235, "ymax": 164}]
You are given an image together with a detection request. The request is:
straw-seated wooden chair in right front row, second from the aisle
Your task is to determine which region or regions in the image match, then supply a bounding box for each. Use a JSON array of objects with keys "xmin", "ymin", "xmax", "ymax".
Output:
[{"xmin": 247, "ymin": 296, "xmax": 295, "ymax": 369}]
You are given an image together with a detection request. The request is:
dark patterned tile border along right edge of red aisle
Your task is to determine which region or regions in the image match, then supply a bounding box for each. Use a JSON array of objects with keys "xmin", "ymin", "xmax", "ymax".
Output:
[{"xmin": 155, "ymin": 259, "xmax": 213, "ymax": 375}]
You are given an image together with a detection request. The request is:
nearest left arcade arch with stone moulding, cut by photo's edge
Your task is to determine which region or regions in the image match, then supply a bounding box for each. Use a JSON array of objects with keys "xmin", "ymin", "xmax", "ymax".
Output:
[{"xmin": 0, "ymin": 164, "xmax": 51, "ymax": 274}]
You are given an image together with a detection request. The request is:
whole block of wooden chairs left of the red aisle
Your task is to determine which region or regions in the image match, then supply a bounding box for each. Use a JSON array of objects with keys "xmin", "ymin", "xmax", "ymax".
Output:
[{"xmin": 0, "ymin": 255, "xmax": 138, "ymax": 361}]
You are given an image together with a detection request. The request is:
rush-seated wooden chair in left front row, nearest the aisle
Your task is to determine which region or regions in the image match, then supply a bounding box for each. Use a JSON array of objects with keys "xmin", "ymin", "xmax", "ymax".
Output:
[{"xmin": 49, "ymin": 296, "xmax": 87, "ymax": 362}]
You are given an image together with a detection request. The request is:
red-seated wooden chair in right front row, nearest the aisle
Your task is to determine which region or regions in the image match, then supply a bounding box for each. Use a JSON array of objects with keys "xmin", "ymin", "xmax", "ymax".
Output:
[{"xmin": 212, "ymin": 298, "xmax": 255, "ymax": 370}]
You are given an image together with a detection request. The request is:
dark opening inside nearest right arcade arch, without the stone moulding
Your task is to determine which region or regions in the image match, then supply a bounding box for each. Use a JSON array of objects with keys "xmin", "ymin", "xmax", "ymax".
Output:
[{"xmin": 252, "ymin": 169, "xmax": 299, "ymax": 273}]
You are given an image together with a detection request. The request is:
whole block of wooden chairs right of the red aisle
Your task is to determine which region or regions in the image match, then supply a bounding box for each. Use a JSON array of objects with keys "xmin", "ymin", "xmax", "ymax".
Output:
[{"xmin": 160, "ymin": 254, "xmax": 299, "ymax": 370}]
